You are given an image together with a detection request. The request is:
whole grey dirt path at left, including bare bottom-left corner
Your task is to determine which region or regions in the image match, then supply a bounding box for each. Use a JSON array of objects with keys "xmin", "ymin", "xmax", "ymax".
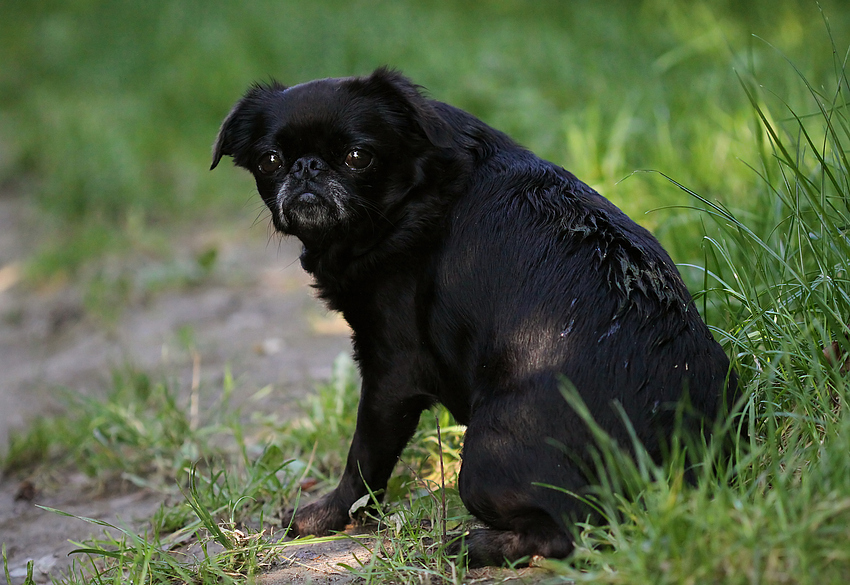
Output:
[{"xmin": 0, "ymin": 198, "xmax": 349, "ymax": 582}]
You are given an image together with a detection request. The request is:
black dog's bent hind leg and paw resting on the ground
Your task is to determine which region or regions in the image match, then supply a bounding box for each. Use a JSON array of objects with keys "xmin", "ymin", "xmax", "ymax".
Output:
[{"xmin": 450, "ymin": 396, "xmax": 589, "ymax": 567}]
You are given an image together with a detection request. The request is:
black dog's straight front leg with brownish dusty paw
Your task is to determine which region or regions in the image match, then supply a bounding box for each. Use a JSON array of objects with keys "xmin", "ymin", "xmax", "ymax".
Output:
[{"xmin": 284, "ymin": 379, "xmax": 432, "ymax": 536}]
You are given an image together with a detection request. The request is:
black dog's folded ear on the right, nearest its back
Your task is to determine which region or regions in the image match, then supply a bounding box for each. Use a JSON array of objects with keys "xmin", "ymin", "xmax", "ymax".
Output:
[{"xmin": 363, "ymin": 67, "xmax": 453, "ymax": 148}]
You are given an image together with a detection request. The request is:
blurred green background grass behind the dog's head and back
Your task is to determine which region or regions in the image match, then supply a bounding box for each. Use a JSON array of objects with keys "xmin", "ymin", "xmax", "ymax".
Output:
[{"xmin": 0, "ymin": 0, "xmax": 850, "ymax": 279}]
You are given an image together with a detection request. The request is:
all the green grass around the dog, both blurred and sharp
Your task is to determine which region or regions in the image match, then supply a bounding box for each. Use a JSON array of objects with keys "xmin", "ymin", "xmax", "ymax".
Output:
[{"xmin": 0, "ymin": 0, "xmax": 850, "ymax": 584}]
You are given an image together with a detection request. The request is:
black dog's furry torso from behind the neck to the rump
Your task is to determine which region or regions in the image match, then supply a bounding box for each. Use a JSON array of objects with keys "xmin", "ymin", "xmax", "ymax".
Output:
[{"xmin": 430, "ymin": 99, "xmax": 736, "ymax": 439}]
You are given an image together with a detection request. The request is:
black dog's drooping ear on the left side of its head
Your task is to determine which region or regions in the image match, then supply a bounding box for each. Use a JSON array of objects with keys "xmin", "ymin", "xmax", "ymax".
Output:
[{"xmin": 210, "ymin": 81, "xmax": 286, "ymax": 170}]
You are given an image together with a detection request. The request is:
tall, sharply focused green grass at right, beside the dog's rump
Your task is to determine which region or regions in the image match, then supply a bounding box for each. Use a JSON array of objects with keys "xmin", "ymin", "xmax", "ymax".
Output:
[{"xmin": 550, "ymin": 24, "xmax": 850, "ymax": 584}]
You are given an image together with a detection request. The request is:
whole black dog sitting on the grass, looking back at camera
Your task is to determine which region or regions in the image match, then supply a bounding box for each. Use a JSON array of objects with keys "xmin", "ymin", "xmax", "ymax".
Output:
[{"xmin": 212, "ymin": 69, "xmax": 735, "ymax": 565}]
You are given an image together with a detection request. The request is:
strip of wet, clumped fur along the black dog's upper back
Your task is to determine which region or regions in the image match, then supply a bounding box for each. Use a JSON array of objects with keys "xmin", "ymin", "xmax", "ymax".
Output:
[{"xmin": 460, "ymin": 146, "xmax": 692, "ymax": 314}]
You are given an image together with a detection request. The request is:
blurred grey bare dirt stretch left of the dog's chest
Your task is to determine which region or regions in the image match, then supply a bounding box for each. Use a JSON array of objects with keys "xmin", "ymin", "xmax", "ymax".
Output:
[{"xmin": 0, "ymin": 201, "xmax": 350, "ymax": 452}]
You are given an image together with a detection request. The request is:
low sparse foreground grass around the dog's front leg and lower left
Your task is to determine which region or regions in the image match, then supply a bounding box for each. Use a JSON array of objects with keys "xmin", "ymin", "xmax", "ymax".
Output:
[{"xmin": 4, "ymin": 352, "xmax": 468, "ymax": 584}]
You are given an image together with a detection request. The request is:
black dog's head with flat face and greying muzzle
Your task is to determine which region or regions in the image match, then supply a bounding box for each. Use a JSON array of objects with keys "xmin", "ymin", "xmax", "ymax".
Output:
[{"xmin": 212, "ymin": 69, "xmax": 451, "ymax": 247}]
